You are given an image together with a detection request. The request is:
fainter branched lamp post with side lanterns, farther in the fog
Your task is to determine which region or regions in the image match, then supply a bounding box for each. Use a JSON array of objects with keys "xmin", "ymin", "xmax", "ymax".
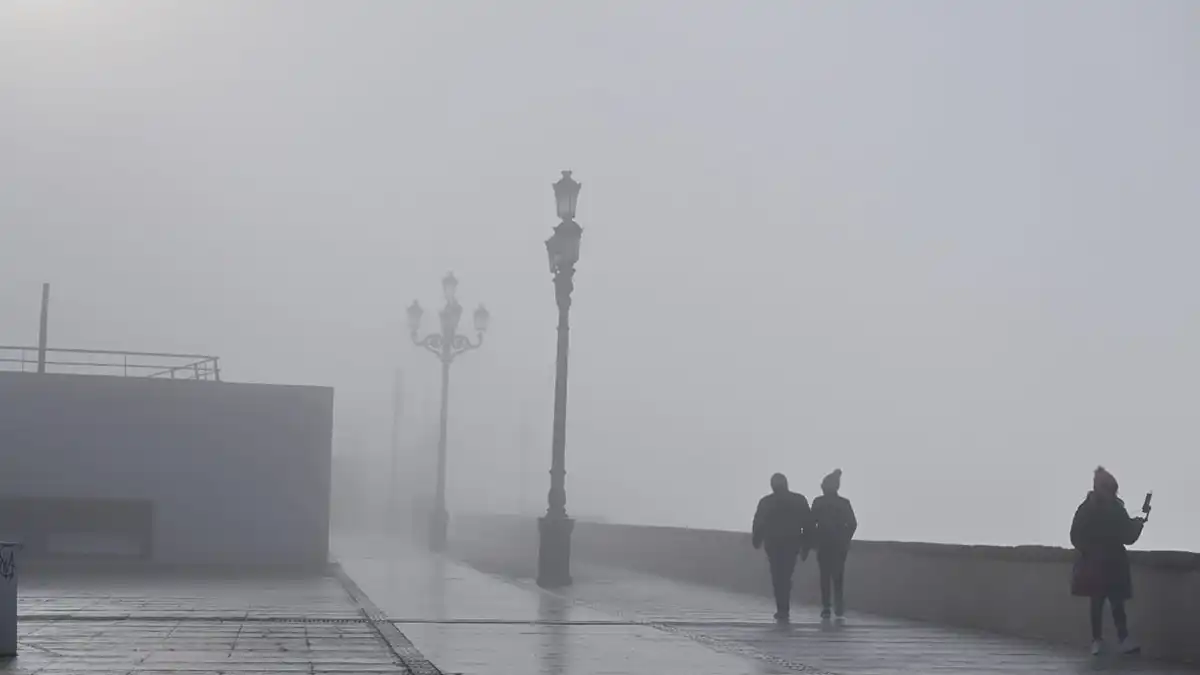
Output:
[{"xmin": 408, "ymin": 271, "xmax": 492, "ymax": 551}]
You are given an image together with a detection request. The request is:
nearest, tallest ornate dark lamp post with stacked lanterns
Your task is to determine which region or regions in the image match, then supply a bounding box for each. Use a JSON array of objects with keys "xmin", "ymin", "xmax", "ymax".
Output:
[{"xmin": 538, "ymin": 171, "xmax": 583, "ymax": 589}]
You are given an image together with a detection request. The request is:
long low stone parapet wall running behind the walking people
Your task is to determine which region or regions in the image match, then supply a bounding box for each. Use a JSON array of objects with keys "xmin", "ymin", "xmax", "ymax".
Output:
[{"xmin": 454, "ymin": 516, "xmax": 1200, "ymax": 662}]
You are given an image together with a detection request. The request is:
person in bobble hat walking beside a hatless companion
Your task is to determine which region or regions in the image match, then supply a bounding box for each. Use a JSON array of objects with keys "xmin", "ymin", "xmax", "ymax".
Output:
[{"xmin": 812, "ymin": 468, "xmax": 858, "ymax": 621}]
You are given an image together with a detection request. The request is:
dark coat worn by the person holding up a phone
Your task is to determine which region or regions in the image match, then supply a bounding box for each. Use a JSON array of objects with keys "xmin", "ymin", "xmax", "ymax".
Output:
[{"xmin": 1070, "ymin": 492, "xmax": 1145, "ymax": 599}]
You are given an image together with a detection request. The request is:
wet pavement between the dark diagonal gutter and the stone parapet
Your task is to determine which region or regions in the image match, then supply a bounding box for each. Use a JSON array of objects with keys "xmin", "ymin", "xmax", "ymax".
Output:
[{"xmin": 335, "ymin": 540, "xmax": 1195, "ymax": 675}]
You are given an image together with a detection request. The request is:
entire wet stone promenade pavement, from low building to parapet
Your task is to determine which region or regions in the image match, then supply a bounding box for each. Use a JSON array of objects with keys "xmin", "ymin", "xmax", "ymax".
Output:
[{"xmin": 7, "ymin": 539, "xmax": 1195, "ymax": 675}]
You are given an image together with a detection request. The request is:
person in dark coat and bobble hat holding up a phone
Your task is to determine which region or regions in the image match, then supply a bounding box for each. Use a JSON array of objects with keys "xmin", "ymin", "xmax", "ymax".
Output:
[{"xmin": 1070, "ymin": 466, "xmax": 1146, "ymax": 655}]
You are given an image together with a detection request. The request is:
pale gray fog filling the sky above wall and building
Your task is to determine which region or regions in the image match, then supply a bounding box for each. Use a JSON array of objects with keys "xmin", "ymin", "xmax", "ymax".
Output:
[{"xmin": 0, "ymin": 0, "xmax": 1200, "ymax": 550}]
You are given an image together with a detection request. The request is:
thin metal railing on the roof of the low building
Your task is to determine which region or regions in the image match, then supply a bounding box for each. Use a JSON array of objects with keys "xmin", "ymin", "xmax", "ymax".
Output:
[{"xmin": 0, "ymin": 345, "xmax": 221, "ymax": 382}]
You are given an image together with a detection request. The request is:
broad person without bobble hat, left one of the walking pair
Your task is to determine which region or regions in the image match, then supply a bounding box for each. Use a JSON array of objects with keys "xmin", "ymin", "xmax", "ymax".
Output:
[{"xmin": 751, "ymin": 473, "xmax": 812, "ymax": 623}]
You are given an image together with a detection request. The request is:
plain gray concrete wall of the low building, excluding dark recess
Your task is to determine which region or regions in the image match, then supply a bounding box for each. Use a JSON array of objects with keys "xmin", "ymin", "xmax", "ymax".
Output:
[{"xmin": 0, "ymin": 372, "xmax": 334, "ymax": 565}]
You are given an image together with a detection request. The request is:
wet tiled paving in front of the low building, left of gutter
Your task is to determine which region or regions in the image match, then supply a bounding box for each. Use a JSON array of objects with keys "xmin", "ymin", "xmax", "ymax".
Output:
[{"xmin": 0, "ymin": 575, "xmax": 409, "ymax": 675}]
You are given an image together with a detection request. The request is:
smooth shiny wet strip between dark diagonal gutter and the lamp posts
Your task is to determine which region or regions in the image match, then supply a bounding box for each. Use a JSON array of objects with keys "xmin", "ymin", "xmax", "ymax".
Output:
[{"xmin": 335, "ymin": 540, "xmax": 794, "ymax": 675}]
